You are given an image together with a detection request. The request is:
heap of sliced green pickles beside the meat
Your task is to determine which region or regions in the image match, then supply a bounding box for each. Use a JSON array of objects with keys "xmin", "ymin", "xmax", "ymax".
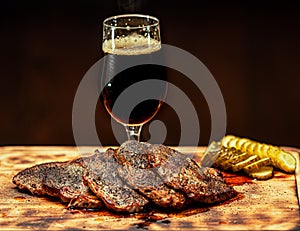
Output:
[{"xmin": 202, "ymin": 135, "xmax": 296, "ymax": 180}]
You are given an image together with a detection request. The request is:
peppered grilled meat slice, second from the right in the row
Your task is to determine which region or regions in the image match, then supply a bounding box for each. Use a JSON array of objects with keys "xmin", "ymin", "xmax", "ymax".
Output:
[{"xmin": 118, "ymin": 164, "xmax": 185, "ymax": 209}]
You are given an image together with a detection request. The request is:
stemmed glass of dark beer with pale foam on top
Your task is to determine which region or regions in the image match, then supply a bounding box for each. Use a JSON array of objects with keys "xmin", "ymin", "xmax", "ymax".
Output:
[{"xmin": 101, "ymin": 14, "xmax": 167, "ymax": 141}]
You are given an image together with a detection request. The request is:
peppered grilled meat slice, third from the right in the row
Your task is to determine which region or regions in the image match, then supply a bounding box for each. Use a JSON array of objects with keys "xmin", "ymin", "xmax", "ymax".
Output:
[{"xmin": 83, "ymin": 153, "xmax": 149, "ymax": 213}]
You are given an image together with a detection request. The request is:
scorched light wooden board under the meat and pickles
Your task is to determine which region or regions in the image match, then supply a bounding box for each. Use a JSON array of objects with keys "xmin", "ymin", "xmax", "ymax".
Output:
[{"xmin": 0, "ymin": 146, "xmax": 300, "ymax": 230}]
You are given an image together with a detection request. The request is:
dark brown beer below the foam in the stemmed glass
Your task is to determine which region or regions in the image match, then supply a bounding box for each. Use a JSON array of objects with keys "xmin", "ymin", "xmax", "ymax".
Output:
[{"xmin": 101, "ymin": 50, "xmax": 167, "ymax": 125}]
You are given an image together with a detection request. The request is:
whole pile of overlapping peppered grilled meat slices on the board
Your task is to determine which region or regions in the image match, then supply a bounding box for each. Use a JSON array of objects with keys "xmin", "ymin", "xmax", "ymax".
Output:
[{"xmin": 13, "ymin": 141, "xmax": 237, "ymax": 213}]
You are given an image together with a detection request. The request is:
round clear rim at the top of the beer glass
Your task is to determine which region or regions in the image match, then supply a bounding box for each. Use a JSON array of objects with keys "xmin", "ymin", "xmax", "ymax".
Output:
[{"xmin": 103, "ymin": 14, "xmax": 159, "ymax": 29}]
